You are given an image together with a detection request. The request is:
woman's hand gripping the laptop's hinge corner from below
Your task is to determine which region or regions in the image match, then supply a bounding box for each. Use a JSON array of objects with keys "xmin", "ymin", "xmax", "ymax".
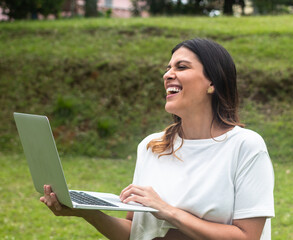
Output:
[{"xmin": 40, "ymin": 185, "xmax": 80, "ymax": 217}]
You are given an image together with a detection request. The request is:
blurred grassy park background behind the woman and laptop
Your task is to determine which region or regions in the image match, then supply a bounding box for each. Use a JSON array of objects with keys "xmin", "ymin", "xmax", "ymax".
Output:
[{"xmin": 0, "ymin": 0, "xmax": 293, "ymax": 240}]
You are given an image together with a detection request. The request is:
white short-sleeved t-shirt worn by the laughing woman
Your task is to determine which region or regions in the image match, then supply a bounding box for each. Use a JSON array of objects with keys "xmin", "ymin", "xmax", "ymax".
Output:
[{"xmin": 130, "ymin": 126, "xmax": 274, "ymax": 240}]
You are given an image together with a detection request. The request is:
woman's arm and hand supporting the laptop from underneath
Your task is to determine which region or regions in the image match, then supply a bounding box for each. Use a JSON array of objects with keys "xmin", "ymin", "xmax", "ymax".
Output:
[{"xmin": 40, "ymin": 185, "xmax": 132, "ymax": 240}]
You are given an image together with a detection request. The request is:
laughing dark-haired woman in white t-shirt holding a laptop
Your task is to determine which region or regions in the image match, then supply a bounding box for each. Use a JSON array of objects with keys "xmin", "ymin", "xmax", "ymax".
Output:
[{"xmin": 40, "ymin": 39, "xmax": 274, "ymax": 240}]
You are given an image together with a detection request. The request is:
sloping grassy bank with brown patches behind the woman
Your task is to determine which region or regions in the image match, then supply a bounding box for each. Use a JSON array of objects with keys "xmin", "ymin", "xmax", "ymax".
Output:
[{"xmin": 0, "ymin": 16, "xmax": 293, "ymax": 159}]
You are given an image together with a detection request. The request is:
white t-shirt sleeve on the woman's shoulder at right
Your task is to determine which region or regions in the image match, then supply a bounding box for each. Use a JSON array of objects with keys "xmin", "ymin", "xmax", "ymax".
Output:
[{"xmin": 233, "ymin": 150, "xmax": 274, "ymax": 219}]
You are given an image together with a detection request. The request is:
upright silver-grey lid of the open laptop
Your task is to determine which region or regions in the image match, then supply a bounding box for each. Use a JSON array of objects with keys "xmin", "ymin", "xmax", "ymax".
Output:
[{"xmin": 14, "ymin": 113, "xmax": 72, "ymax": 207}]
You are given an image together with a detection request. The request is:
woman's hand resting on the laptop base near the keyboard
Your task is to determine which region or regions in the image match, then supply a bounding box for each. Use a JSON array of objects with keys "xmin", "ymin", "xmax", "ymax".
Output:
[{"xmin": 120, "ymin": 184, "xmax": 173, "ymax": 220}]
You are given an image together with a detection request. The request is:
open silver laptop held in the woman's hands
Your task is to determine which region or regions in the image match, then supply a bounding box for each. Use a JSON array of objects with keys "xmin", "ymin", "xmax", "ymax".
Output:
[{"xmin": 14, "ymin": 113, "xmax": 157, "ymax": 212}]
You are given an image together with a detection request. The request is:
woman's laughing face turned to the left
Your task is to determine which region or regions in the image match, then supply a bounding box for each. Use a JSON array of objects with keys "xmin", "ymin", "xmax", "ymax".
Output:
[{"xmin": 163, "ymin": 47, "xmax": 211, "ymax": 118}]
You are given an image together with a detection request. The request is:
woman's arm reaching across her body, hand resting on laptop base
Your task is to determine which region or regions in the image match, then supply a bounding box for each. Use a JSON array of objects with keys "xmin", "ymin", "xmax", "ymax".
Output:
[{"xmin": 120, "ymin": 185, "xmax": 265, "ymax": 240}]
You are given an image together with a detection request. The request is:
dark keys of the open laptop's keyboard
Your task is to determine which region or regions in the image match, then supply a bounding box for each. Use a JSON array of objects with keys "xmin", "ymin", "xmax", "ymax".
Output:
[{"xmin": 69, "ymin": 191, "xmax": 118, "ymax": 207}]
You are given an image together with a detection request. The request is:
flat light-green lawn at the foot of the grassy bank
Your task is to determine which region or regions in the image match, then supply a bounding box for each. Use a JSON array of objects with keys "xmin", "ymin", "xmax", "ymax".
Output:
[{"xmin": 0, "ymin": 155, "xmax": 293, "ymax": 240}]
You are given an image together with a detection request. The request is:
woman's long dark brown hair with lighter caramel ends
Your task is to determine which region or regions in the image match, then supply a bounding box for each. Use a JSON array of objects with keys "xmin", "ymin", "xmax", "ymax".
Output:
[{"xmin": 147, "ymin": 38, "xmax": 244, "ymax": 157}]
